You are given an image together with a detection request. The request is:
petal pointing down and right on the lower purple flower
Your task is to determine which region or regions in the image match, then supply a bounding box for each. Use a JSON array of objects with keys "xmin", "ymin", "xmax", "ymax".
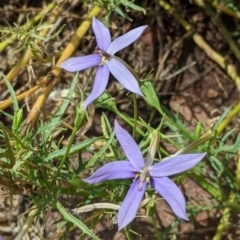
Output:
[{"xmin": 151, "ymin": 177, "xmax": 188, "ymax": 220}]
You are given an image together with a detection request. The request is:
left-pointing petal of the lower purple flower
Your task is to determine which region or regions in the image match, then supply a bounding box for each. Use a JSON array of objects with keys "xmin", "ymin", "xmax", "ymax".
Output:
[{"xmin": 83, "ymin": 161, "xmax": 136, "ymax": 184}]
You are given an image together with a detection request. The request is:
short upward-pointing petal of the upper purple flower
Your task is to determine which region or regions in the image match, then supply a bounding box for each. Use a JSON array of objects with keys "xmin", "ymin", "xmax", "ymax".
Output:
[{"xmin": 92, "ymin": 17, "xmax": 111, "ymax": 52}]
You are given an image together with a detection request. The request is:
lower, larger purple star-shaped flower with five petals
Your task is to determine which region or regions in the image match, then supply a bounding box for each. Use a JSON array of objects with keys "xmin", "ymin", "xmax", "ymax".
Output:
[{"xmin": 84, "ymin": 121, "xmax": 206, "ymax": 230}]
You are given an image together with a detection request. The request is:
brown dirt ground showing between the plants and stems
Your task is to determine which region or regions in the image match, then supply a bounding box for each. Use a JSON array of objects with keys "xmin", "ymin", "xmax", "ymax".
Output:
[{"xmin": 0, "ymin": 0, "xmax": 240, "ymax": 240}]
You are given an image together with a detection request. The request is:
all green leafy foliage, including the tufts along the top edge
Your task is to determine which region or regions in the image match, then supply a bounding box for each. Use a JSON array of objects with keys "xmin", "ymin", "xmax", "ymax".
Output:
[{"xmin": 0, "ymin": 0, "xmax": 240, "ymax": 239}]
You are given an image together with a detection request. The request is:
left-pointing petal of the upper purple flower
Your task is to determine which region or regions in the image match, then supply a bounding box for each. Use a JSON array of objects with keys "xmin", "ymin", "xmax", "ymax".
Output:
[{"xmin": 59, "ymin": 54, "xmax": 102, "ymax": 72}]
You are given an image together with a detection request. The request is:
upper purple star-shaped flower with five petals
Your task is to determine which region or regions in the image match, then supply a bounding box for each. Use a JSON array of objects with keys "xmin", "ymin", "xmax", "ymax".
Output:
[{"xmin": 60, "ymin": 18, "xmax": 147, "ymax": 108}]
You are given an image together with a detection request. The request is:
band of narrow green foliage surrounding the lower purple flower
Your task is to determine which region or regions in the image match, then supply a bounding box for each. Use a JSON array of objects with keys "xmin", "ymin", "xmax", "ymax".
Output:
[{"xmin": 0, "ymin": 74, "xmax": 240, "ymax": 239}]
